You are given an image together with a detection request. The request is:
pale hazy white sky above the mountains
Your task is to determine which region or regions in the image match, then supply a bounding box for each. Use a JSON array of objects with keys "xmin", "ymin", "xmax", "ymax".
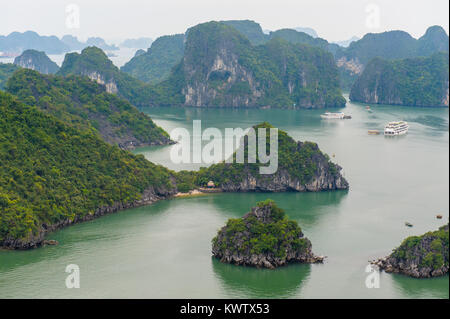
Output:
[{"xmin": 0, "ymin": 0, "xmax": 449, "ymax": 42}]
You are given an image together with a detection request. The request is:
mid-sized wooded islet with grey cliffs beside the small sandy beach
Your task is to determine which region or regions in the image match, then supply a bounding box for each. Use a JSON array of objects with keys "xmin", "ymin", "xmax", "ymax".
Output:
[{"xmin": 198, "ymin": 123, "xmax": 349, "ymax": 192}]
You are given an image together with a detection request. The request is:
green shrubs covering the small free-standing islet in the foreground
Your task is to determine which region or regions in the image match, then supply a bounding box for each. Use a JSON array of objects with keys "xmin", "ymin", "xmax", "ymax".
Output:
[{"xmin": 212, "ymin": 199, "xmax": 309, "ymax": 258}]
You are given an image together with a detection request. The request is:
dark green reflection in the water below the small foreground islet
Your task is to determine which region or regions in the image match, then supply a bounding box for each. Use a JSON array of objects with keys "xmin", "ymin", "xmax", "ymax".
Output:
[{"xmin": 211, "ymin": 257, "xmax": 312, "ymax": 298}]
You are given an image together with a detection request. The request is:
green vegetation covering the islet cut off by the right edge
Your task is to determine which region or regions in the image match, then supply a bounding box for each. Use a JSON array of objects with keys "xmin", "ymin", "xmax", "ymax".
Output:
[{"xmin": 390, "ymin": 224, "xmax": 449, "ymax": 270}]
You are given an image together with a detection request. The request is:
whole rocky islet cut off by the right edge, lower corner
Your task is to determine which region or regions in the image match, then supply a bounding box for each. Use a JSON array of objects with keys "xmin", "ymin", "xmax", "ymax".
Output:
[{"xmin": 373, "ymin": 224, "xmax": 449, "ymax": 278}]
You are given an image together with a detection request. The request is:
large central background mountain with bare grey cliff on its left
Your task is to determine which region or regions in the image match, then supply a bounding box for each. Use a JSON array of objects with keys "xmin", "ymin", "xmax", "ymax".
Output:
[{"xmin": 174, "ymin": 22, "xmax": 345, "ymax": 108}]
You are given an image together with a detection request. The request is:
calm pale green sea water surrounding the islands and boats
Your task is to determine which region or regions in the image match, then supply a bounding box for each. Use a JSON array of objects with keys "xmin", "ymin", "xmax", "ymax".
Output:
[{"xmin": 0, "ymin": 98, "xmax": 449, "ymax": 298}]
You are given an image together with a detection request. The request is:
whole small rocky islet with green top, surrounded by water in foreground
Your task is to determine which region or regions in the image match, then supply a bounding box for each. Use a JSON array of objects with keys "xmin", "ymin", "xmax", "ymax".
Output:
[{"xmin": 212, "ymin": 199, "xmax": 324, "ymax": 269}]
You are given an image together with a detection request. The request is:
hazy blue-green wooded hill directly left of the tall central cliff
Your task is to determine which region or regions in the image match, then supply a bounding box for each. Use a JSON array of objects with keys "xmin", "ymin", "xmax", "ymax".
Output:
[{"xmin": 120, "ymin": 34, "xmax": 184, "ymax": 84}]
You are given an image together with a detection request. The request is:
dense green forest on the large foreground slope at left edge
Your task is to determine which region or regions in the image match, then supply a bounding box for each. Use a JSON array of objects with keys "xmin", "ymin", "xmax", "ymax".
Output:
[{"xmin": 0, "ymin": 92, "xmax": 173, "ymax": 245}]
